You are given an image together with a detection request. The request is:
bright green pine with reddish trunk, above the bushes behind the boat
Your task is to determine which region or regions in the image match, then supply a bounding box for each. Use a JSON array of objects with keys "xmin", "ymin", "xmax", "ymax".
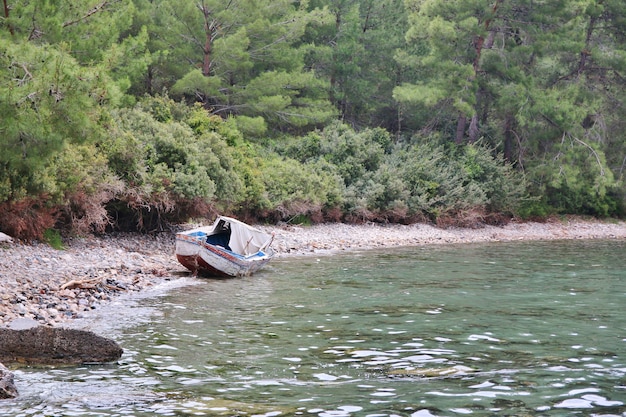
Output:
[{"xmin": 138, "ymin": 0, "xmax": 335, "ymax": 134}]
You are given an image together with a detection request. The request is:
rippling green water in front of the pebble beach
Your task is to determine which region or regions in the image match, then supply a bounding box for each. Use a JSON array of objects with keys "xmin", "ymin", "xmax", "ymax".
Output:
[{"xmin": 0, "ymin": 241, "xmax": 626, "ymax": 417}]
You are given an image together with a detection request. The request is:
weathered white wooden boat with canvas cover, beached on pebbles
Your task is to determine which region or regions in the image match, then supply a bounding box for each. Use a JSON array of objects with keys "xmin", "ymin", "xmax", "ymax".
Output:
[{"xmin": 176, "ymin": 216, "xmax": 274, "ymax": 277}]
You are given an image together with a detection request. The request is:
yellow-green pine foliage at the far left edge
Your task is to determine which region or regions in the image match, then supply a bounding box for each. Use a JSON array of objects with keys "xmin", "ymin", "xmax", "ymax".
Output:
[{"xmin": 0, "ymin": 42, "xmax": 106, "ymax": 202}]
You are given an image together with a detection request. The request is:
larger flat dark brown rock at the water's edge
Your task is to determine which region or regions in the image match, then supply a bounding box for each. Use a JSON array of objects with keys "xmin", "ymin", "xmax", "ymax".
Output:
[{"xmin": 0, "ymin": 326, "xmax": 124, "ymax": 365}]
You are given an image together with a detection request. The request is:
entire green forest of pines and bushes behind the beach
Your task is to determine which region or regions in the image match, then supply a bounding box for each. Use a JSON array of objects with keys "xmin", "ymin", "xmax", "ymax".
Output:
[{"xmin": 0, "ymin": 0, "xmax": 626, "ymax": 239}]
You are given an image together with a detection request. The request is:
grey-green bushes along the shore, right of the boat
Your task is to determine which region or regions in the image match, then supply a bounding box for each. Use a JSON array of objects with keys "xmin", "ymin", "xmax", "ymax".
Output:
[{"xmin": 284, "ymin": 124, "xmax": 525, "ymax": 223}]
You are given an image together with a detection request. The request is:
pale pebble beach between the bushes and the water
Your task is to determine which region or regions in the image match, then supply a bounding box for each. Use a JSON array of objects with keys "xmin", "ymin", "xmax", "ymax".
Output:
[{"xmin": 0, "ymin": 219, "xmax": 626, "ymax": 326}]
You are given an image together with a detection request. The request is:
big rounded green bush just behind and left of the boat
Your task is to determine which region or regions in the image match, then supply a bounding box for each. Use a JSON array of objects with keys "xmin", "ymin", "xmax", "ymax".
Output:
[{"xmin": 99, "ymin": 102, "xmax": 243, "ymax": 227}]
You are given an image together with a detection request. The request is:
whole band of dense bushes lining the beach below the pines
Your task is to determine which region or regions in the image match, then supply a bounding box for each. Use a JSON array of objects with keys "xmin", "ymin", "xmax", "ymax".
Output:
[{"xmin": 4, "ymin": 88, "xmax": 524, "ymax": 237}]
